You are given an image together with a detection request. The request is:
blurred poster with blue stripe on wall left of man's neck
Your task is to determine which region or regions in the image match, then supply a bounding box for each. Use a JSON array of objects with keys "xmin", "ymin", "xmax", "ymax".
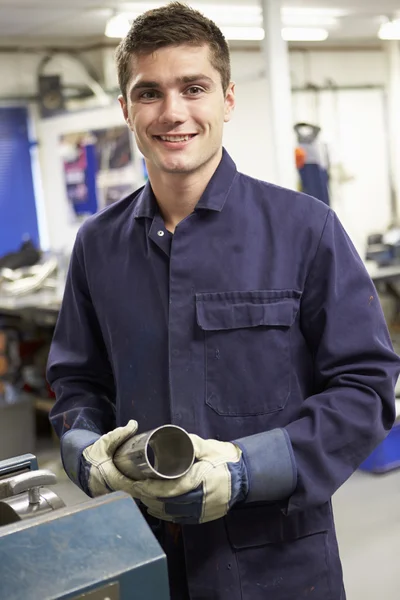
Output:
[{"xmin": 60, "ymin": 126, "xmax": 143, "ymax": 217}]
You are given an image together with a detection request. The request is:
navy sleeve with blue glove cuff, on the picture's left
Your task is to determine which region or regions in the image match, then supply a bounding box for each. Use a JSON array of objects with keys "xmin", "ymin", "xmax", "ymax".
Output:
[{"xmin": 47, "ymin": 233, "xmax": 116, "ymax": 483}]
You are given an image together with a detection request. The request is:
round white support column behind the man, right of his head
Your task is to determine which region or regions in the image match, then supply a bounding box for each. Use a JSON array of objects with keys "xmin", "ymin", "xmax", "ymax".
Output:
[{"xmin": 261, "ymin": 0, "xmax": 298, "ymax": 189}]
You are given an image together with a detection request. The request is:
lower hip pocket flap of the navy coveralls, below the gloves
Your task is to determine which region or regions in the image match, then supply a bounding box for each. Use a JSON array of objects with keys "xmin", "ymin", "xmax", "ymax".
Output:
[{"xmin": 225, "ymin": 503, "xmax": 332, "ymax": 550}]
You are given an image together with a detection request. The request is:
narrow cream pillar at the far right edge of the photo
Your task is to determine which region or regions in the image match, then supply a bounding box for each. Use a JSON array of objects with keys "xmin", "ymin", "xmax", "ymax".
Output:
[{"xmin": 386, "ymin": 40, "xmax": 400, "ymax": 226}]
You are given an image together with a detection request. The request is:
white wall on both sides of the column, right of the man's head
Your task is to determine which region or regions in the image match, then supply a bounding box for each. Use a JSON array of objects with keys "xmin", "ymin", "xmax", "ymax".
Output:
[{"xmin": 225, "ymin": 51, "xmax": 391, "ymax": 256}]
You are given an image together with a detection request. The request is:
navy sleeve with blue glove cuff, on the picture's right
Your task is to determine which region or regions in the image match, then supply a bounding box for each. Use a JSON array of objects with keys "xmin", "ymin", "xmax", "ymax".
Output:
[{"xmin": 234, "ymin": 211, "xmax": 400, "ymax": 513}]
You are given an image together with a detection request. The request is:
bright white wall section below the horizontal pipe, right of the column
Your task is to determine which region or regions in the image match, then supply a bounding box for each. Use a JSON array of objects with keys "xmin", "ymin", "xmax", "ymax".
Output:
[{"xmin": 293, "ymin": 89, "xmax": 391, "ymax": 254}]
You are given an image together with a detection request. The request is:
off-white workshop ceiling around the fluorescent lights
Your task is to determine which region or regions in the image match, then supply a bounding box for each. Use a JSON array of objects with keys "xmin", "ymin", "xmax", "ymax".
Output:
[{"xmin": 0, "ymin": 0, "xmax": 400, "ymax": 47}]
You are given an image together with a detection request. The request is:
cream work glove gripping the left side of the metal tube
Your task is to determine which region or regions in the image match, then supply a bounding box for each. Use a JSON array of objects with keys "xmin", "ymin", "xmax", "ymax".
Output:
[{"xmin": 79, "ymin": 420, "xmax": 138, "ymax": 498}]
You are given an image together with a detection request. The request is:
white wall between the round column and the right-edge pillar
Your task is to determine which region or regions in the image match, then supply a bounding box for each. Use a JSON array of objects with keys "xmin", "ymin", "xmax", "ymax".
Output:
[{"xmin": 291, "ymin": 49, "xmax": 391, "ymax": 255}]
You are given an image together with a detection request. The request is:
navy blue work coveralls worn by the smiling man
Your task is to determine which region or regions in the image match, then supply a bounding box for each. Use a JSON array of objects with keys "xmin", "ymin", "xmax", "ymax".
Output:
[{"xmin": 48, "ymin": 151, "xmax": 400, "ymax": 600}]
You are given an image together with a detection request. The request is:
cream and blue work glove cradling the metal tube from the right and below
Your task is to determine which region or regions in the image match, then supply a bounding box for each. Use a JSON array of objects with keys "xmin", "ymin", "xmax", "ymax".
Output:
[{"xmin": 130, "ymin": 434, "xmax": 248, "ymax": 525}]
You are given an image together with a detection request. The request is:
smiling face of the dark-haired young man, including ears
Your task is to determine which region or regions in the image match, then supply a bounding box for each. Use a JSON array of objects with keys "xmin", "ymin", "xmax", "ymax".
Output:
[{"xmin": 119, "ymin": 45, "xmax": 234, "ymax": 178}]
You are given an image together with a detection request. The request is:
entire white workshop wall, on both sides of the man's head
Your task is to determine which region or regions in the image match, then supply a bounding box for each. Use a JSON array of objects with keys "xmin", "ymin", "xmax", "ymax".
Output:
[{"xmin": 0, "ymin": 49, "xmax": 390, "ymax": 253}]
